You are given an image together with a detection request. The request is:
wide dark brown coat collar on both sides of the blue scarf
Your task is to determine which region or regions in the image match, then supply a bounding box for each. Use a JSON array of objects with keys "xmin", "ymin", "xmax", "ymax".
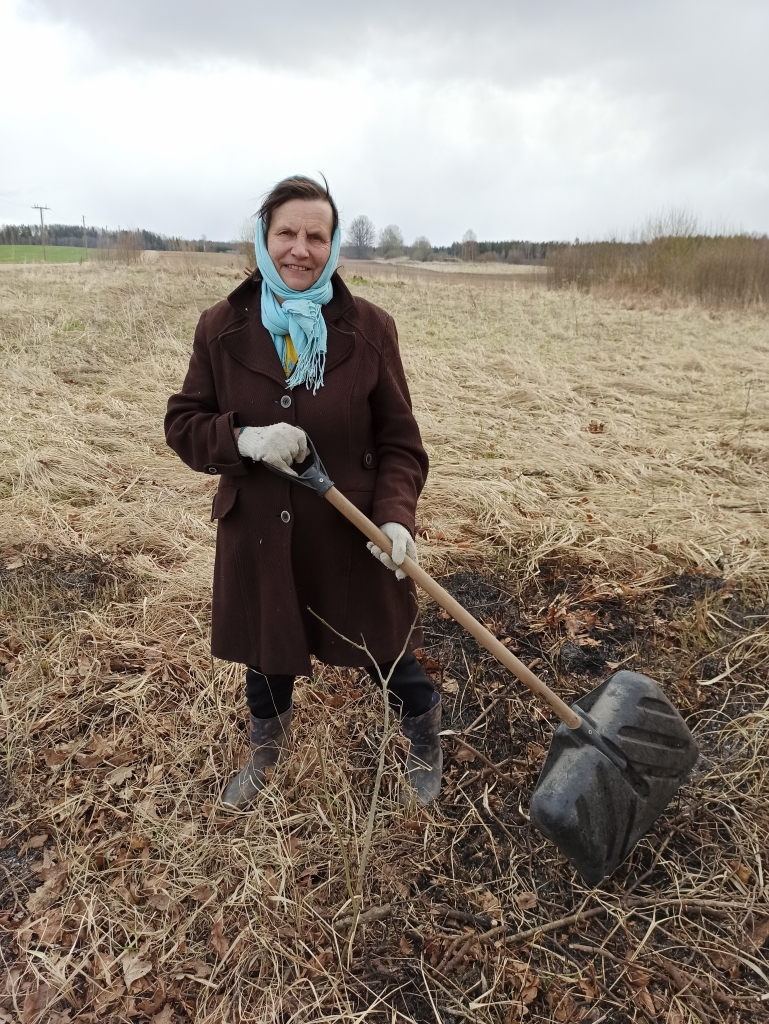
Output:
[{"xmin": 220, "ymin": 271, "xmax": 355, "ymax": 386}]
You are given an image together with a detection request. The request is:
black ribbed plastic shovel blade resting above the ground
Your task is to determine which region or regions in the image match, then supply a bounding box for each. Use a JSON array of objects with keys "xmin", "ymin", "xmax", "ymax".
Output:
[{"xmin": 530, "ymin": 672, "xmax": 699, "ymax": 886}]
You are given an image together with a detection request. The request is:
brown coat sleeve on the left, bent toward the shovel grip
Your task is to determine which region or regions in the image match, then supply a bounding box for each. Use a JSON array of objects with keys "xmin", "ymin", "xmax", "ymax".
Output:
[{"xmin": 164, "ymin": 312, "xmax": 248, "ymax": 476}]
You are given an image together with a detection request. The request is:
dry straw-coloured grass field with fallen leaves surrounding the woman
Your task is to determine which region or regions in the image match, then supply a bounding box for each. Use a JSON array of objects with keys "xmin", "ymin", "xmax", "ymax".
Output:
[{"xmin": 0, "ymin": 260, "xmax": 769, "ymax": 1024}]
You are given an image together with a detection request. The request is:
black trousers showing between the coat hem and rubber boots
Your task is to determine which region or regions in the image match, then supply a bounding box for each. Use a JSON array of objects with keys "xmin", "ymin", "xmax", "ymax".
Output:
[{"xmin": 246, "ymin": 654, "xmax": 434, "ymax": 718}]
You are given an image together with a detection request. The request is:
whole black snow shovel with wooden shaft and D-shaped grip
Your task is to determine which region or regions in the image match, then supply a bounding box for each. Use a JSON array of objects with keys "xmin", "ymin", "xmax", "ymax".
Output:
[{"xmin": 264, "ymin": 437, "xmax": 698, "ymax": 886}]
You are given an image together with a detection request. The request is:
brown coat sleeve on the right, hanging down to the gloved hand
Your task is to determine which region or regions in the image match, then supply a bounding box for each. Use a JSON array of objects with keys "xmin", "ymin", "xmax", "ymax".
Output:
[{"xmin": 371, "ymin": 316, "xmax": 429, "ymax": 536}]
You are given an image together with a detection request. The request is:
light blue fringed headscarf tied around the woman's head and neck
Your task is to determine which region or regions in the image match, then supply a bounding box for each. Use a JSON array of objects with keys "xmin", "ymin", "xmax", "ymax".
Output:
[{"xmin": 254, "ymin": 211, "xmax": 341, "ymax": 394}]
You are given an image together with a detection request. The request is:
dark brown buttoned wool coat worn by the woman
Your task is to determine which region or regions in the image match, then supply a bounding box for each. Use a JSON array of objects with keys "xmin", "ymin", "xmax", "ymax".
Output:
[{"xmin": 165, "ymin": 274, "xmax": 428, "ymax": 675}]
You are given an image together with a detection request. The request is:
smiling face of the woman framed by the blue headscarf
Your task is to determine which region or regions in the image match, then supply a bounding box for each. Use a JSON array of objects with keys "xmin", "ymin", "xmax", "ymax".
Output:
[{"xmin": 267, "ymin": 199, "xmax": 334, "ymax": 292}]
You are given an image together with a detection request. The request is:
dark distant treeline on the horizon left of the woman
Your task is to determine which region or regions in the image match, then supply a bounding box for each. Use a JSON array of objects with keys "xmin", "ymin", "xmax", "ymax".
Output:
[{"xmin": 0, "ymin": 224, "xmax": 238, "ymax": 253}]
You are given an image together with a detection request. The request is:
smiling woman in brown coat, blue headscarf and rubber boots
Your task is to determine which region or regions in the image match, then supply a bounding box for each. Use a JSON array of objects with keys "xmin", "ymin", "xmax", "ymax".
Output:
[{"xmin": 165, "ymin": 176, "xmax": 442, "ymax": 810}]
